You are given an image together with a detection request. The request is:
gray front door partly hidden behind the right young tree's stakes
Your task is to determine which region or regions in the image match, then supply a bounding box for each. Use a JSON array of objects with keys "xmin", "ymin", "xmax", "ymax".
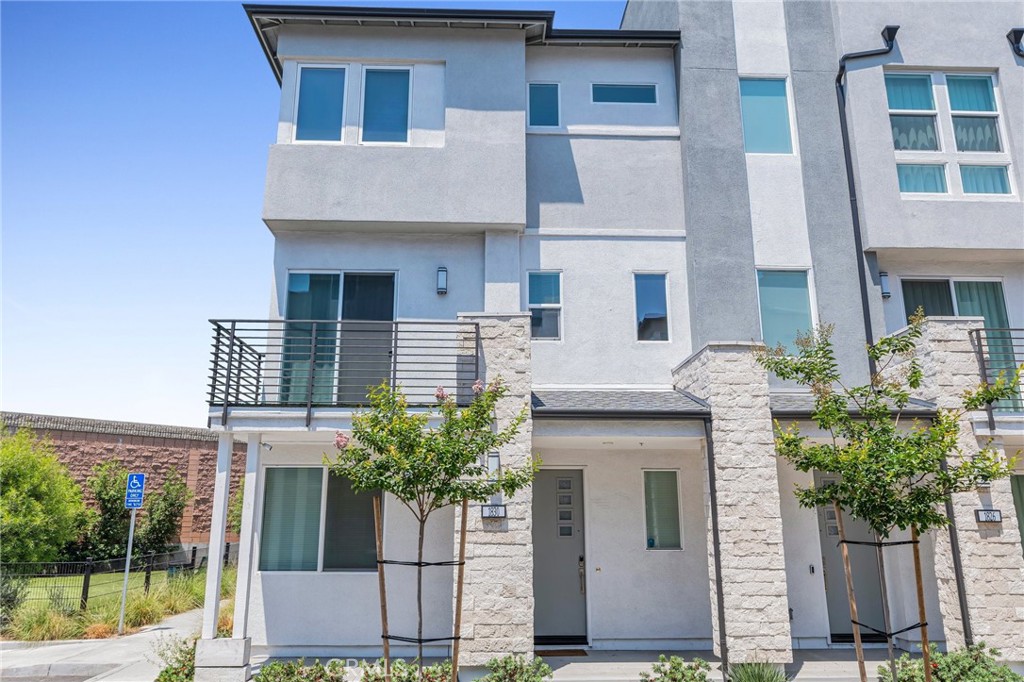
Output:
[{"xmin": 814, "ymin": 472, "xmax": 885, "ymax": 642}]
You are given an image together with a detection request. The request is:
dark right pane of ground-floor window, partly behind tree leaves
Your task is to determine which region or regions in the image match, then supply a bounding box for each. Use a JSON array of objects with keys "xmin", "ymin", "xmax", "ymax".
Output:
[{"xmin": 324, "ymin": 474, "xmax": 380, "ymax": 570}]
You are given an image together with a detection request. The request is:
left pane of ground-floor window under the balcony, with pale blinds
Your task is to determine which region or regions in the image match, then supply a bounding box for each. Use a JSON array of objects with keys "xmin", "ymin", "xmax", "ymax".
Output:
[{"xmin": 259, "ymin": 467, "xmax": 324, "ymax": 570}]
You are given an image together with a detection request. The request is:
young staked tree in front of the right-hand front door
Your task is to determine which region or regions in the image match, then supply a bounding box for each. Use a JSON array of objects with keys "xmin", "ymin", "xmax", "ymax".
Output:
[{"xmin": 758, "ymin": 311, "xmax": 1024, "ymax": 682}]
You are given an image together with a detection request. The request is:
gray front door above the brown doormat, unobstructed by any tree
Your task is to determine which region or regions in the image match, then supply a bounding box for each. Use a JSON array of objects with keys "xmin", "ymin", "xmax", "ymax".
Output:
[{"xmin": 534, "ymin": 469, "xmax": 587, "ymax": 644}]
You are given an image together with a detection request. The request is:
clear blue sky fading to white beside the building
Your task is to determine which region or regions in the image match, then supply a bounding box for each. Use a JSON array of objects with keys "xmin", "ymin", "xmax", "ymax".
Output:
[{"xmin": 0, "ymin": 0, "xmax": 625, "ymax": 426}]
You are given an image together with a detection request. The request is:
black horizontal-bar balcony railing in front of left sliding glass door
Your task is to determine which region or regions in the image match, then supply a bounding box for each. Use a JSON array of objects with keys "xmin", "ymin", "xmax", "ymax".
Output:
[{"xmin": 209, "ymin": 319, "xmax": 480, "ymax": 426}]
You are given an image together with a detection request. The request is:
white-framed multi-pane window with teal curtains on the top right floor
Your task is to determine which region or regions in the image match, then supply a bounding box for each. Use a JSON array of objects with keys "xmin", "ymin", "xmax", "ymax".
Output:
[{"xmin": 885, "ymin": 72, "xmax": 1012, "ymax": 197}]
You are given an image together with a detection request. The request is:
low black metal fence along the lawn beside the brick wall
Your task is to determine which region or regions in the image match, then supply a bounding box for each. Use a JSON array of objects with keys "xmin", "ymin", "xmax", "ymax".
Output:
[{"xmin": 0, "ymin": 543, "xmax": 233, "ymax": 611}]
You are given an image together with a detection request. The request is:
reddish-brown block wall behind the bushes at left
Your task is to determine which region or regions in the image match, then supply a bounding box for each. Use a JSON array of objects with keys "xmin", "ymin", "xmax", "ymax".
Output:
[{"xmin": 3, "ymin": 417, "xmax": 246, "ymax": 545}]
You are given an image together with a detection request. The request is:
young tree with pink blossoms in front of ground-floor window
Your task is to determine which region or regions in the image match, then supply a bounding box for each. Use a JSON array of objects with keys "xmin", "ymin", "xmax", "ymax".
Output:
[{"xmin": 329, "ymin": 379, "xmax": 539, "ymax": 677}]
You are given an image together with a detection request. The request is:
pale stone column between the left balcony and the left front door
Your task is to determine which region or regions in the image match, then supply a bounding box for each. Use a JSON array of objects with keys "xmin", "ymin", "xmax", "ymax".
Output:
[{"xmin": 453, "ymin": 312, "xmax": 534, "ymax": 668}]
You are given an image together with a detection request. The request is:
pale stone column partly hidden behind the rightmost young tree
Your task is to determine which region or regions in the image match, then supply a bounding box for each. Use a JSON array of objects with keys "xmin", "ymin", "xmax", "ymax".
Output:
[{"xmin": 918, "ymin": 317, "xmax": 1024, "ymax": 660}]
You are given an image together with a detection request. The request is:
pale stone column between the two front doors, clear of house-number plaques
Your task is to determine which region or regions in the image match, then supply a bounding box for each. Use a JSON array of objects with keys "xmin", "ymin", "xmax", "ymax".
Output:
[{"xmin": 673, "ymin": 343, "xmax": 793, "ymax": 663}]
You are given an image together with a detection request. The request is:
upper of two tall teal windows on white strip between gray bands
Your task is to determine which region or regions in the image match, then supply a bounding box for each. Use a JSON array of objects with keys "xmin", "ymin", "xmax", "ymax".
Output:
[{"xmin": 739, "ymin": 78, "xmax": 793, "ymax": 154}]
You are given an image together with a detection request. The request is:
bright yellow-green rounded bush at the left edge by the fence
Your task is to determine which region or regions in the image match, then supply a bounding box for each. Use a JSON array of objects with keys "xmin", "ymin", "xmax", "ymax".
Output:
[{"xmin": 0, "ymin": 427, "xmax": 85, "ymax": 563}]
